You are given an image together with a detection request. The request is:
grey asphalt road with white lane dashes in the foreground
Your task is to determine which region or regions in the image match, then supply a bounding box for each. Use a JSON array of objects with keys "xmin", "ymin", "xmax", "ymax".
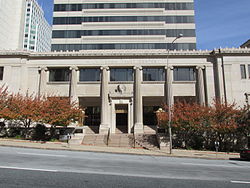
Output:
[{"xmin": 0, "ymin": 147, "xmax": 250, "ymax": 188}]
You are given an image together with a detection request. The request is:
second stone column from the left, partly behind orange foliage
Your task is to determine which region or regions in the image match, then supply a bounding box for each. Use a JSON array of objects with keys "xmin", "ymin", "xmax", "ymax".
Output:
[{"xmin": 69, "ymin": 67, "xmax": 78, "ymax": 104}]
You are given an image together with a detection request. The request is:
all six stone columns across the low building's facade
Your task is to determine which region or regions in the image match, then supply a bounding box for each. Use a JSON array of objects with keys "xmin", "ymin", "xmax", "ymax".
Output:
[{"xmin": 38, "ymin": 66, "xmax": 205, "ymax": 134}]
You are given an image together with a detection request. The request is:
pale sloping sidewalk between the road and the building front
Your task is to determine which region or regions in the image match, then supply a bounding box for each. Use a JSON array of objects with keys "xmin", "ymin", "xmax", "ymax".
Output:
[{"xmin": 0, "ymin": 139, "xmax": 239, "ymax": 160}]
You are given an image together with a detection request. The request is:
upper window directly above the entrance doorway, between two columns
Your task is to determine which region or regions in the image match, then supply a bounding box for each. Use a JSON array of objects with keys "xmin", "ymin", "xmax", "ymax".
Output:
[{"xmin": 110, "ymin": 68, "xmax": 133, "ymax": 81}]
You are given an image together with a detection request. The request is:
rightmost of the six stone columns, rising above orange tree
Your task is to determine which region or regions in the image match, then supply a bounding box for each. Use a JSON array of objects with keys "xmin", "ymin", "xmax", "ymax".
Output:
[{"xmin": 196, "ymin": 66, "xmax": 205, "ymax": 105}]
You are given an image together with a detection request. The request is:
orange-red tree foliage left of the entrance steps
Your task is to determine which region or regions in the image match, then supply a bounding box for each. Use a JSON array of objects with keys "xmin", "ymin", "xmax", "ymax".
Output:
[{"xmin": 0, "ymin": 87, "xmax": 82, "ymax": 131}]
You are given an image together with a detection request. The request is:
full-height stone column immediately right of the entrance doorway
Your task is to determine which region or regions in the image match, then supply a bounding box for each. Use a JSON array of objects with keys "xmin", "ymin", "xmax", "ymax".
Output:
[{"xmin": 134, "ymin": 67, "xmax": 143, "ymax": 134}]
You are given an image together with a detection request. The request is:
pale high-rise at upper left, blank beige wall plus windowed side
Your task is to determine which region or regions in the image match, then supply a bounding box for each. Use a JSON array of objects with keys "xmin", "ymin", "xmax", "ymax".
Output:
[{"xmin": 0, "ymin": 0, "xmax": 52, "ymax": 52}]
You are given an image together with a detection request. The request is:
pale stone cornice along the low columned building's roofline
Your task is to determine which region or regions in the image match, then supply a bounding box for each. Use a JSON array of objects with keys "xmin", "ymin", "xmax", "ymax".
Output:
[{"xmin": 0, "ymin": 48, "xmax": 250, "ymax": 59}]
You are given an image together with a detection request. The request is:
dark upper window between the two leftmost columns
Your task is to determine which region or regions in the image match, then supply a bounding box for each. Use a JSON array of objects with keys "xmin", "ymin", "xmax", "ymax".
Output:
[{"xmin": 49, "ymin": 68, "xmax": 70, "ymax": 82}]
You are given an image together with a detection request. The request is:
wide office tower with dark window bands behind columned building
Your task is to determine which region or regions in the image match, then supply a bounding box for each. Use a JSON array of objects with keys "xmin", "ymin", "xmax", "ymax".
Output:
[{"xmin": 52, "ymin": 0, "xmax": 196, "ymax": 51}]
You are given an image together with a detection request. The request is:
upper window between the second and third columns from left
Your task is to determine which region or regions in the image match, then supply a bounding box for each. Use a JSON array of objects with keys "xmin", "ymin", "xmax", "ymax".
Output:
[{"xmin": 79, "ymin": 68, "xmax": 100, "ymax": 82}]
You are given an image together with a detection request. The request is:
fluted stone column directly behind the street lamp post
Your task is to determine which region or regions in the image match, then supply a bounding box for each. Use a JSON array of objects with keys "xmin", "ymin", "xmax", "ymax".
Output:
[{"xmin": 165, "ymin": 67, "xmax": 174, "ymax": 106}]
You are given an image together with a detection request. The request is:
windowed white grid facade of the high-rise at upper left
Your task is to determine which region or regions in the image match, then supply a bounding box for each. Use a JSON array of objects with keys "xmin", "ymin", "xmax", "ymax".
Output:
[{"xmin": 23, "ymin": 0, "xmax": 51, "ymax": 52}]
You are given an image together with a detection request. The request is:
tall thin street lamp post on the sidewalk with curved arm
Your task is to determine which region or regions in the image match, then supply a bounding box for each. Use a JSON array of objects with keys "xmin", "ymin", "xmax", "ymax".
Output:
[{"xmin": 167, "ymin": 34, "xmax": 183, "ymax": 154}]
